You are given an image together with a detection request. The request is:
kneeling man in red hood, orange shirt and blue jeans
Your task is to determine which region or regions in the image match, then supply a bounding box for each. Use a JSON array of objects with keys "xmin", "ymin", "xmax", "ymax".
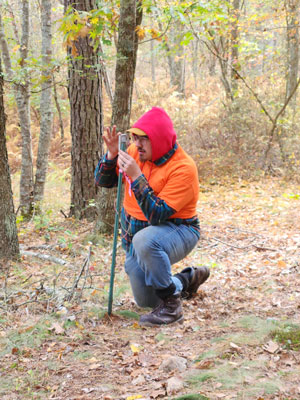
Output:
[{"xmin": 95, "ymin": 107, "xmax": 209, "ymax": 326}]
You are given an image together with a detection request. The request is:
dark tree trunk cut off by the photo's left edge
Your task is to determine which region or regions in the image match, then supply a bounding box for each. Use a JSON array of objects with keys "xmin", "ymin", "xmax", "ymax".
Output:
[{"xmin": 0, "ymin": 58, "xmax": 19, "ymax": 259}]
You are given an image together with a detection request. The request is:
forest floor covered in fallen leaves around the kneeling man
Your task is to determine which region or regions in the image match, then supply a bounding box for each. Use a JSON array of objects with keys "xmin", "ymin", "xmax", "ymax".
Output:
[{"xmin": 0, "ymin": 177, "xmax": 300, "ymax": 400}]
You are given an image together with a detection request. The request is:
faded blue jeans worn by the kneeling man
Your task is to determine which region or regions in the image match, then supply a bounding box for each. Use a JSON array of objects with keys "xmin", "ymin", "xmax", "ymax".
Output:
[{"xmin": 125, "ymin": 222, "xmax": 199, "ymax": 307}]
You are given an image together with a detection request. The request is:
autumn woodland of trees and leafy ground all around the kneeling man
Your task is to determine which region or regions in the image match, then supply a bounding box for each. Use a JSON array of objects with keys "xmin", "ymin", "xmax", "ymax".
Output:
[{"xmin": 0, "ymin": 0, "xmax": 300, "ymax": 400}]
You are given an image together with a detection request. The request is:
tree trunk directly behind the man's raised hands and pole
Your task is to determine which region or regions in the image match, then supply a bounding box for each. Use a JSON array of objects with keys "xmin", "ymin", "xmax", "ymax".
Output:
[{"xmin": 95, "ymin": 0, "xmax": 142, "ymax": 233}]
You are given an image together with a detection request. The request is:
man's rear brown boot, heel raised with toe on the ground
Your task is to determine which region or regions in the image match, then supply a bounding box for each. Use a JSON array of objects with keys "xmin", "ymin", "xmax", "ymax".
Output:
[{"xmin": 175, "ymin": 267, "xmax": 210, "ymax": 299}]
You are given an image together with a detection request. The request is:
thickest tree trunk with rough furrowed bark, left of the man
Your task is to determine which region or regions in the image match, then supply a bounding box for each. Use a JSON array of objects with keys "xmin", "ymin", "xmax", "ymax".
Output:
[{"xmin": 65, "ymin": 0, "xmax": 102, "ymax": 219}]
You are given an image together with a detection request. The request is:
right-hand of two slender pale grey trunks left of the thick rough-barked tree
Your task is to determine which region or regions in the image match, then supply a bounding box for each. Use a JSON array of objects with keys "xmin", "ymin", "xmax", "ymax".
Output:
[{"xmin": 34, "ymin": 0, "xmax": 52, "ymax": 204}]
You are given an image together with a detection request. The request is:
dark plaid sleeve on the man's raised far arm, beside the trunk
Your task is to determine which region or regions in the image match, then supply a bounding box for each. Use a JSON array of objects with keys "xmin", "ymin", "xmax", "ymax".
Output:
[{"xmin": 95, "ymin": 154, "xmax": 118, "ymax": 188}]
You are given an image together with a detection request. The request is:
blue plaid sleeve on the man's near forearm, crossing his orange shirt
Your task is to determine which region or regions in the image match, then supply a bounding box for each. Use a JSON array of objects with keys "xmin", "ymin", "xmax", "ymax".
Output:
[{"xmin": 131, "ymin": 175, "xmax": 176, "ymax": 225}]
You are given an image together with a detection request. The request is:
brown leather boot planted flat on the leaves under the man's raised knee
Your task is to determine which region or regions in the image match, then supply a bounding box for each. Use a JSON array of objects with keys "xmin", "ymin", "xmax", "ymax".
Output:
[{"xmin": 140, "ymin": 294, "xmax": 183, "ymax": 326}]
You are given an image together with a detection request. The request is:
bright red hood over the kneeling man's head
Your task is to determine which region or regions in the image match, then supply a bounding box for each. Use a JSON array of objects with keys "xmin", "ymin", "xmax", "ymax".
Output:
[{"xmin": 132, "ymin": 107, "xmax": 177, "ymax": 161}]
